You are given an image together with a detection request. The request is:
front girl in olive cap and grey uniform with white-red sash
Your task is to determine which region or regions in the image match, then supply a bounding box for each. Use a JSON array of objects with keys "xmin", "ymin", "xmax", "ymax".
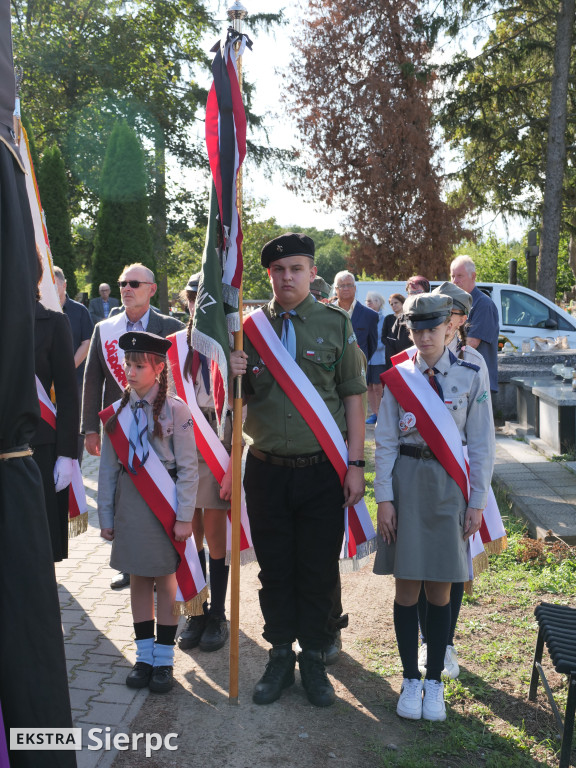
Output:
[{"xmin": 374, "ymin": 293, "xmax": 494, "ymax": 720}]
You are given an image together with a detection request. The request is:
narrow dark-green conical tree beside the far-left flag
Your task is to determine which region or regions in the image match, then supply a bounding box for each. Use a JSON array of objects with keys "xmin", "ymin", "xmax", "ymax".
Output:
[{"xmin": 38, "ymin": 144, "xmax": 78, "ymax": 298}]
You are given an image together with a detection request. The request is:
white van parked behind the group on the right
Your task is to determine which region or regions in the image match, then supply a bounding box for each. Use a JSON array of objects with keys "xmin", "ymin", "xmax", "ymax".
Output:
[{"xmin": 356, "ymin": 280, "xmax": 576, "ymax": 349}]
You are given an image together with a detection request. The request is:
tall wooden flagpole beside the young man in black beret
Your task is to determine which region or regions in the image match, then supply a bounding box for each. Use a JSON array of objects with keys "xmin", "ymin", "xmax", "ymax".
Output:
[{"xmin": 228, "ymin": 2, "xmax": 248, "ymax": 704}]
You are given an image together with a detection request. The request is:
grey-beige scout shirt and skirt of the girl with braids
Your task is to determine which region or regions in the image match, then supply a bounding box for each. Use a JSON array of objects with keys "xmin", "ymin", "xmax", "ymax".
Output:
[{"xmin": 98, "ymin": 384, "xmax": 198, "ymax": 576}]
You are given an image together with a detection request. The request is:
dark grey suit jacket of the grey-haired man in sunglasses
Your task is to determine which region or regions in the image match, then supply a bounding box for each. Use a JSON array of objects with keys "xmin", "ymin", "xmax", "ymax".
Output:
[{"xmin": 81, "ymin": 311, "xmax": 185, "ymax": 434}]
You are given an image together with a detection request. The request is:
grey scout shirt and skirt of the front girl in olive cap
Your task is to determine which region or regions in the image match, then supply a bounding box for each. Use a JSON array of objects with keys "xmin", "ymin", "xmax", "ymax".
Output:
[{"xmin": 374, "ymin": 349, "xmax": 495, "ymax": 582}]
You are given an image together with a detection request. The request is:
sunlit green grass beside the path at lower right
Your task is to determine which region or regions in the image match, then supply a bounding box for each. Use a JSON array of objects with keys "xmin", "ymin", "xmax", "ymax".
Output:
[{"xmin": 357, "ymin": 472, "xmax": 576, "ymax": 768}]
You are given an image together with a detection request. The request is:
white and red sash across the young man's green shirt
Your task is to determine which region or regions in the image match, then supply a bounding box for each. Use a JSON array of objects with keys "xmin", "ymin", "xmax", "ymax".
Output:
[{"xmin": 244, "ymin": 309, "xmax": 376, "ymax": 564}]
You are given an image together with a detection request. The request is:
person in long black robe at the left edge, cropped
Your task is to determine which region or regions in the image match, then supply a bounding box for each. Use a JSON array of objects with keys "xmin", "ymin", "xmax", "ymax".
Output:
[{"xmin": 0, "ymin": 0, "xmax": 76, "ymax": 768}]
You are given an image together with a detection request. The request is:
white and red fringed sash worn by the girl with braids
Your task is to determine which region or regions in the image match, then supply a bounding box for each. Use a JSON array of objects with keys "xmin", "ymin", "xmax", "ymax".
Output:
[{"xmin": 99, "ymin": 400, "xmax": 208, "ymax": 615}]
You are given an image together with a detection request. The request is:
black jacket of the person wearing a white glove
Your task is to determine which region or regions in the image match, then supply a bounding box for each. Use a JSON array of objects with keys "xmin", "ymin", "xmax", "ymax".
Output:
[{"xmin": 31, "ymin": 301, "xmax": 79, "ymax": 459}]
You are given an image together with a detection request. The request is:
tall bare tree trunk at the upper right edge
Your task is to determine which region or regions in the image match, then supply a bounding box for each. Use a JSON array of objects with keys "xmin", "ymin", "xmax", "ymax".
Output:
[{"xmin": 538, "ymin": 0, "xmax": 576, "ymax": 301}]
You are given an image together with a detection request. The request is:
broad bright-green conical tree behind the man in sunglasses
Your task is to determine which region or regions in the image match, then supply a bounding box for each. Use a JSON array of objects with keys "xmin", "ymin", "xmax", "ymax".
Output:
[{"xmin": 92, "ymin": 121, "xmax": 155, "ymax": 298}]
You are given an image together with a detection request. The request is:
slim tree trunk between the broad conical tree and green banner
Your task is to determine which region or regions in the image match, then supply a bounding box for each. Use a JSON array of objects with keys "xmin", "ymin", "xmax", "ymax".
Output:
[{"xmin": 150, "ymin": 127, "xmax": 169, "ymax": 315}]
